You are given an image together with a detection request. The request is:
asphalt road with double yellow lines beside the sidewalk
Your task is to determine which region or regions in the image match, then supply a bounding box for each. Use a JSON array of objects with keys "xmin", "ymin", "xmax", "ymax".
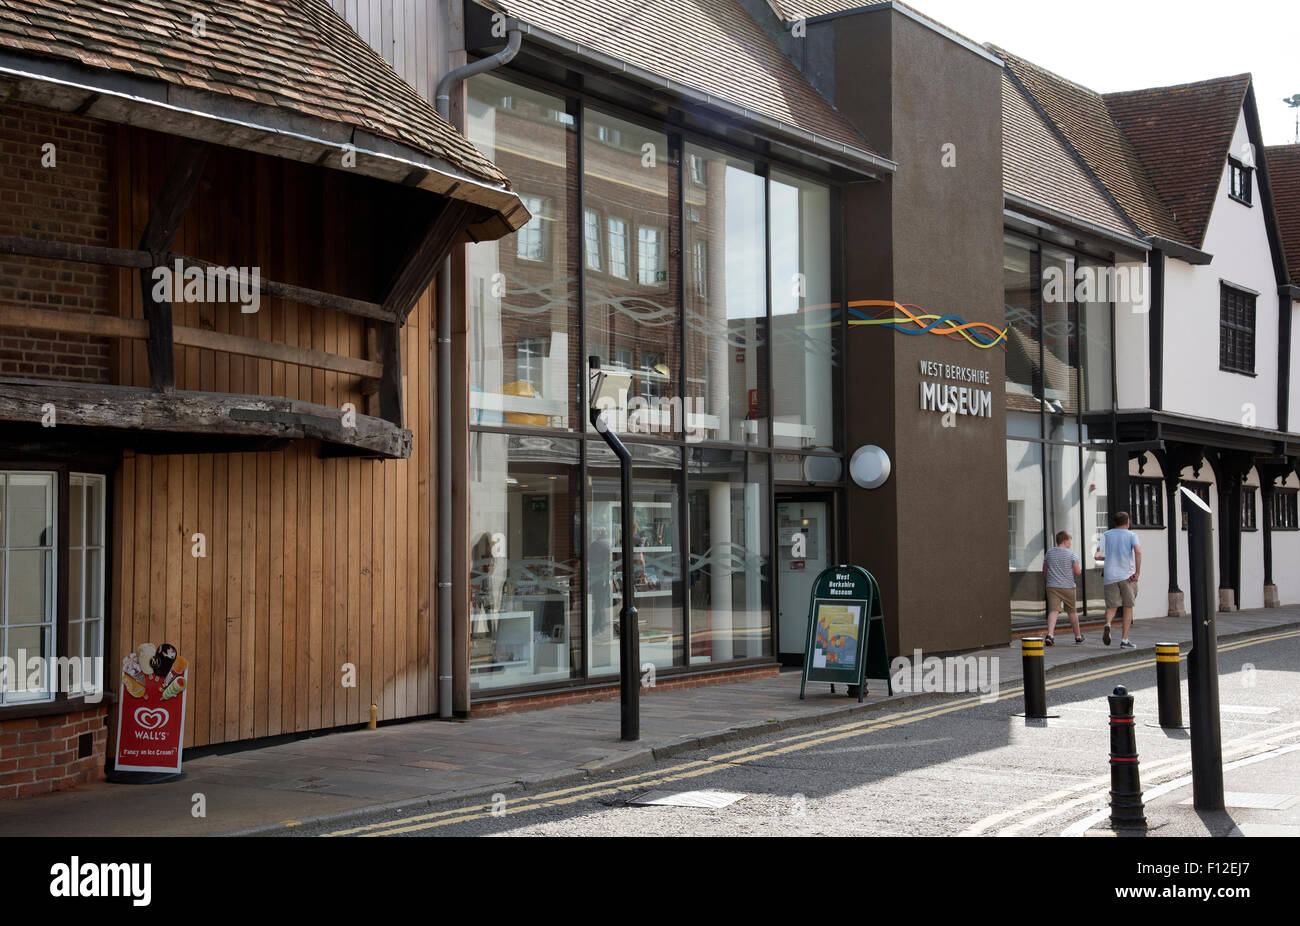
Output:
[{"xmin": 292, "ymin": 631, "xmax": 1300, "ymax": 836}]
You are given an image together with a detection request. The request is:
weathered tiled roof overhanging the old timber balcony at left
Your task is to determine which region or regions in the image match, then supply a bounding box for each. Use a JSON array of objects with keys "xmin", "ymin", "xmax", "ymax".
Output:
[{"xmin": 0, "ymin": 0, "xmax": 508, "ymax": 187}]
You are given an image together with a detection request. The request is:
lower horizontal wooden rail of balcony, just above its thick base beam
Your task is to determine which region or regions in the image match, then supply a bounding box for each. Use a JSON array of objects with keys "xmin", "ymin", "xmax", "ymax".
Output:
[{"xmin": 0, "ymin": 306, "xmax": 384, "ymax": 381}]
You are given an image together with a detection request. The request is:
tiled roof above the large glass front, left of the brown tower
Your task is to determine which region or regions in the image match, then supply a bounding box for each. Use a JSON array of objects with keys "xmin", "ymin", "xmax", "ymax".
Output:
[{"xmin": 480, "ymin": 0, "xmax": 878, "ymax": 155}]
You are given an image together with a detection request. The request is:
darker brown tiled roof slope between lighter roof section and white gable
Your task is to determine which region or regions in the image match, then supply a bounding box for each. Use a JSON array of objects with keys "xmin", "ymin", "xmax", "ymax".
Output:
[{"xmin": 985, "ymin": 46, "xmax": 1199, "ymax": 246}]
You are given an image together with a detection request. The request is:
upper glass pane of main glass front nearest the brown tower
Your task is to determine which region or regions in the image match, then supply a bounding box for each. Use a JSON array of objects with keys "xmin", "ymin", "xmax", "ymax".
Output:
[{"xmin": 770, "ymin": 172, "xmax": 841, "ymax": 450}]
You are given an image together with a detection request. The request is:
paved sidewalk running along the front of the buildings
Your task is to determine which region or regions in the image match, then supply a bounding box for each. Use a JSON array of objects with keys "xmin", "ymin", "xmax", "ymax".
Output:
[{"xmin": 0, "ymin": 607, "xmax": 1300, "ymax": 836}]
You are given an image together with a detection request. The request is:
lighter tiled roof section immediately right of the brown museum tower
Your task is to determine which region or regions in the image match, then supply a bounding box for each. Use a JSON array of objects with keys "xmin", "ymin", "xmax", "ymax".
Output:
[{"xmin": 1002, "ymin": 72, "xmax": 1135, "ymax": 237}]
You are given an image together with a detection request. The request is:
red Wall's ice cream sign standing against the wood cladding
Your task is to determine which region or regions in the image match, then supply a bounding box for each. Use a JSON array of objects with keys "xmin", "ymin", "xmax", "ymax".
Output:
[{"xmin": 114, "ymin": 642, "xmax": 190, "ymax": 773}]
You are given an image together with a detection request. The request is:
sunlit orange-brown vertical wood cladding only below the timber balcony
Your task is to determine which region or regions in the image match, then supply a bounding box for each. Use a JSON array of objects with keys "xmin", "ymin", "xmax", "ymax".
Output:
[{"xmin": 113, "ymin": 292, "xmax": 437, "ymax": 747}]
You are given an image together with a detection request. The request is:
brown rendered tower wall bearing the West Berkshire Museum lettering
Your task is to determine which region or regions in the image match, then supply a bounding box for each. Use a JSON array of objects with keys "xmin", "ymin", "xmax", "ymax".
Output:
[{"xmin": 835, "ymin": 10, "xmax": 1010, "ymax": 654}]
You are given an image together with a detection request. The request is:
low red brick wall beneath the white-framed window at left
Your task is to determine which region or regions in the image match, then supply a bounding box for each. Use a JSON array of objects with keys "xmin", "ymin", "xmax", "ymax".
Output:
[{"xmin": 0, "ymin": 704, "xmax": 108, "ymax": 800}]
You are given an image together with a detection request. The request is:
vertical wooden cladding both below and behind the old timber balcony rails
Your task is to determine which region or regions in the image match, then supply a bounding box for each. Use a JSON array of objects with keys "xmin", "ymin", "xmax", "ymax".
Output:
[{"xmin": 112, "ymin": 122, "xmax": 437, "ymax": 748}]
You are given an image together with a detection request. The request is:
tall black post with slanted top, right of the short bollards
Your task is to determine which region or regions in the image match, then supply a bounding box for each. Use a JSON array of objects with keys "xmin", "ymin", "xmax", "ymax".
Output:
[{"xmin": 1184, "ymin": 489, "xmax": 1223, "ymax": 810}]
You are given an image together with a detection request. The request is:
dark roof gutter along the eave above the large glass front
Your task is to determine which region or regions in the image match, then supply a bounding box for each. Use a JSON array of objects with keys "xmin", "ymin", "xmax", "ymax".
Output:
[{"xmin": 499, "ymin": 22, "xmax": 898, "ymax": 178}]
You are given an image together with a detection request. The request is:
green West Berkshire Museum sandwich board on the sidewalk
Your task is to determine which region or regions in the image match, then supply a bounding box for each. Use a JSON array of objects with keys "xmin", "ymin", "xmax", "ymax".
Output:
[{"xmin": 800, "ymin": 566, "xmax": 893, "ymax": 701}]
